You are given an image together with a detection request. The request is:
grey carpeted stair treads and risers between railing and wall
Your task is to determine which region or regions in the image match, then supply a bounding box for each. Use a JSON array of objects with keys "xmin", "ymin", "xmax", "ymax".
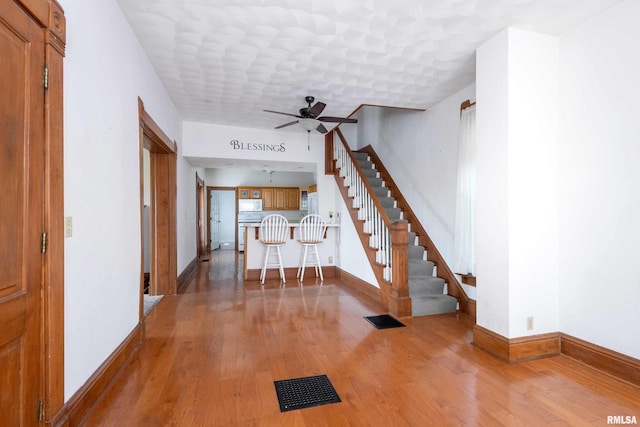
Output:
[{"xmin": 353, "ymin": 152, "xmax": 458, "ymax": 316}]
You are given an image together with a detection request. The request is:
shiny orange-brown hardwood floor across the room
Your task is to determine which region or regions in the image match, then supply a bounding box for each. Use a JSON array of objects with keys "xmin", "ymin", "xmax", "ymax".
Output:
[{"xmin": 84, "ymin": 251, "xmax": 640, "ymax": 426}]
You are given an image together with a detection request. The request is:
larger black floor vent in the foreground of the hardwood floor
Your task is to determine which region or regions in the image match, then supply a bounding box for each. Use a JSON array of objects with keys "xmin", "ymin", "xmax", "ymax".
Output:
[{"xmin": 274, "ymin": 375, "xmax": 342, "ymax": 412}]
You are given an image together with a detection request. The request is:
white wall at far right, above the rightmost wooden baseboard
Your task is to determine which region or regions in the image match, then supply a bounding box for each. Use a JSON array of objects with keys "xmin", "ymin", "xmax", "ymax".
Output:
[{"xmin": 559, "ymin": 0, "xmax": 640, "ymax": 359}]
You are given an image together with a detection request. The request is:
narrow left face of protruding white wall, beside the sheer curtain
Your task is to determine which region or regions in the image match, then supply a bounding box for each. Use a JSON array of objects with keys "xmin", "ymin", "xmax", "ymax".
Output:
[{"xmin": 476, "ymin": 31, "xmax": 510, "ymax": 337}]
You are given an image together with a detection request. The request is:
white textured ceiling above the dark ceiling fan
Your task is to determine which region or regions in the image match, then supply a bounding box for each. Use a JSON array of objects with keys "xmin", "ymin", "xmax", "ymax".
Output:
[{"xmin": 118, "ymin": 0, "xmax": 619, "ymax": 132}]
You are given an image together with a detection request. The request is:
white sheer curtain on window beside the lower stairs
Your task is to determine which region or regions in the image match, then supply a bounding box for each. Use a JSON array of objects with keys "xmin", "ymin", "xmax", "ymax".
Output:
[{"xmin": 454, "ymin": 105, "xmax": 476, "ymax": 275}]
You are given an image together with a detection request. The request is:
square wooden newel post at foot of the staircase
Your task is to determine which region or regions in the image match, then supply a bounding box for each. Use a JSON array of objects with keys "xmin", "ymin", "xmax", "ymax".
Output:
[{"xmin": 389, "ymin": 220, "xmax": 411, "ymax": 317}]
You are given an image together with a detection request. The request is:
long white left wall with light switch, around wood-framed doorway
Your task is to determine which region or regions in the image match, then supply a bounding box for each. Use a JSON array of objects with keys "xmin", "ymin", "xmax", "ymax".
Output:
[{"xmin": 60, "ymin": 0, "xmax": 196, "ymax": 400}]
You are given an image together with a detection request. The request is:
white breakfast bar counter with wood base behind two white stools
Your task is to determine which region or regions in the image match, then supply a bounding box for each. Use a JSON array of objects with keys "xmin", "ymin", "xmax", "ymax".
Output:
[{"xmin": 242, "ymin": 221, "xmax": 340, "ymax": 282}]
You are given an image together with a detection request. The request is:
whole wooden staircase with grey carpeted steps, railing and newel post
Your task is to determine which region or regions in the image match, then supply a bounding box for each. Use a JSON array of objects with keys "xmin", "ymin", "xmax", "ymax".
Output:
[{"xmin": 326, "ymin": 129, "xmax": 469, "ymax": 317}]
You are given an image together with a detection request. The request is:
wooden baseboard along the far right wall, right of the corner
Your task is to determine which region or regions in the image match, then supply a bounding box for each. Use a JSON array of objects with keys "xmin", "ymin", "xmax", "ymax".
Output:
[{"xmin": 560, "ymin": 334, "xmax": 640, "ymax": 387}]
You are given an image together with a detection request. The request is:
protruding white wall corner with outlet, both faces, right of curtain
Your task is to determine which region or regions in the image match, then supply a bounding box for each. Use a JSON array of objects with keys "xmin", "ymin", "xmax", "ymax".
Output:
[{"xmin": 476, "ymin": 29, "xmax": 559, "ymax": 338}]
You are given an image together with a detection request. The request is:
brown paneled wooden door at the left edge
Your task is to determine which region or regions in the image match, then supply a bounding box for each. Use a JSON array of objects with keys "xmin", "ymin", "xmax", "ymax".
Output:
[{"xmin": 0, "ymin": 0, "xmax": 45, "ymax": 426}]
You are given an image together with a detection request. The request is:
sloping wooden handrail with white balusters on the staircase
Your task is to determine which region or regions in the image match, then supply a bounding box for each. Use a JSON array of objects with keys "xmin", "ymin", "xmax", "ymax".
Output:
[{"xmin": 333, "ymin": 128, "xmax": 393, "ymax": 282}]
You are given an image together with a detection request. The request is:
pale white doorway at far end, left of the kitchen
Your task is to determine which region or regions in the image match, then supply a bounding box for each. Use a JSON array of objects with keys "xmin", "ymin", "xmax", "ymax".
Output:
[{"xmin": 207, "ymin": 187, "xmax": 238, "ymax": 251}]
